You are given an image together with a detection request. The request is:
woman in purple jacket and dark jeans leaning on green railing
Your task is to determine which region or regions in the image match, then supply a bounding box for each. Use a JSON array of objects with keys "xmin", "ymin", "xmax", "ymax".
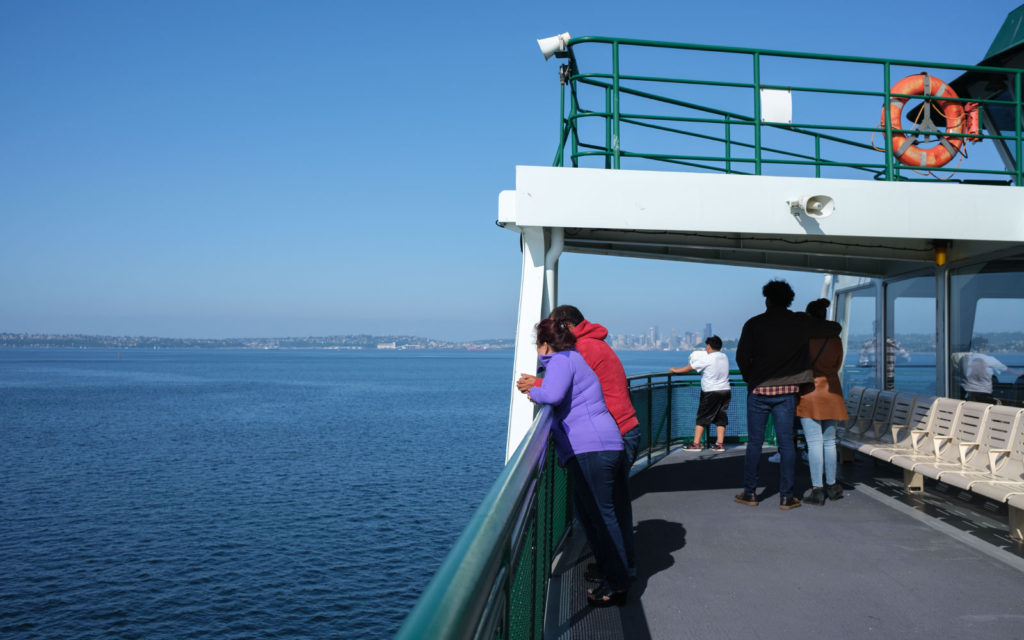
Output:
[{"xmin": 528, "ymin": 318, "xmax": 633, "ymax": 606}]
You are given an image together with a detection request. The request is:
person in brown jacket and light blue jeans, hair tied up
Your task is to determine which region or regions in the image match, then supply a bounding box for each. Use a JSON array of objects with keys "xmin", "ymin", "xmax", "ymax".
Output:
[{"xmin": 797, "ymin": 298, "xmax": 849, "ymax": 506}]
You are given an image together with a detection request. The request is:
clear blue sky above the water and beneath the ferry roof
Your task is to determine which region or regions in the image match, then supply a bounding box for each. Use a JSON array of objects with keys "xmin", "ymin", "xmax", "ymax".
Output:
[{"xmin": 0, "ymin": 0, "xmax": 1018, "ymax": 339}]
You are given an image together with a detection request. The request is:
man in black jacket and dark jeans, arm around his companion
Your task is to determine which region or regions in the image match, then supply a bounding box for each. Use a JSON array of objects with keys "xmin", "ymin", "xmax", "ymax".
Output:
[{"xmin": 734, "ymin": 280, "xmax": 840, "ymax": 509}]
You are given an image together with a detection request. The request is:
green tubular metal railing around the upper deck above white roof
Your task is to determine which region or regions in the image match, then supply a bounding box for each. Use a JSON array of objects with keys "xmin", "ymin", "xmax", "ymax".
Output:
[{"xmin": 555, "ymin": 36, "xmax": 1024, "ymax": 185}]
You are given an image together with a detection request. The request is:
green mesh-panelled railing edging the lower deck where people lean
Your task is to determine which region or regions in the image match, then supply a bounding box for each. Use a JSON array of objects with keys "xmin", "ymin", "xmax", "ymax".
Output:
[{"xmin": 396, "ymin": 372, "xmax": 761, "ymax": 640}]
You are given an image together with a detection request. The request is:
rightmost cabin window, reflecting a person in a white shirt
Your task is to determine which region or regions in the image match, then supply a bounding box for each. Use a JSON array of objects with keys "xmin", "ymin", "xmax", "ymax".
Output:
[{"xmin": 949, "ymin": 258, "xmax": 1024, "ymax": 407}]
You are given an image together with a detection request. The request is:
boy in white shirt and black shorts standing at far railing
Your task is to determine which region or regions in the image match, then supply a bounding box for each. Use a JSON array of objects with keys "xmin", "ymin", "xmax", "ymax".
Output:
[{"xmin": 669, "ymin": 336, "xmax": 732, "ymax": 452}]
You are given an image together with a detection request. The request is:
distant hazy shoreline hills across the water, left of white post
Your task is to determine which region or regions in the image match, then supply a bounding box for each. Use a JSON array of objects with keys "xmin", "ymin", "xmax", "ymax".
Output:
[{"xmin": 0, "ymin": 333, "xmax": 514, "ymax": 350}]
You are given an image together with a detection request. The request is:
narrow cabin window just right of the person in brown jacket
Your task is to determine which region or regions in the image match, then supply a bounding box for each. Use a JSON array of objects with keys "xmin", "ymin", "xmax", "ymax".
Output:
[{"xmin": 836, "ymin": 287, "xmax": 878, "ymax": 389}]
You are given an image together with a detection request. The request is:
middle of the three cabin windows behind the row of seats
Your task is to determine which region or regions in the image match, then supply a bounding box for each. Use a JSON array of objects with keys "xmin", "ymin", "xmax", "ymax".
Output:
[{"xmin": 885, "ymin": 275, "xmax": 936, "ymax": 394}]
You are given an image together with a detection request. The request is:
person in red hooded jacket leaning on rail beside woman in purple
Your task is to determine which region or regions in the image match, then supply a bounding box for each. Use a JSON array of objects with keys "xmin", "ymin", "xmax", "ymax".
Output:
[{"xmin": 516, "ymin": 304, "xmax": 640, "ymax": 583}]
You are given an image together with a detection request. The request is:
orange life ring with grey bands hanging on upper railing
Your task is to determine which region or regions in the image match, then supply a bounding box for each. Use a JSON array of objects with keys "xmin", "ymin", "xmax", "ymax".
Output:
[{"xmin": 882, "ymin": 73, "xmax": 966, "ymax": 167}]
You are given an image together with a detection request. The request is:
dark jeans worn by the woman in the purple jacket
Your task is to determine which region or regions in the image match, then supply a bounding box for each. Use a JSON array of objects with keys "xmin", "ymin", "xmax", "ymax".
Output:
[{"xmin": 568, "ymin": 451, "xmax": 633, "ymax": 591}]
